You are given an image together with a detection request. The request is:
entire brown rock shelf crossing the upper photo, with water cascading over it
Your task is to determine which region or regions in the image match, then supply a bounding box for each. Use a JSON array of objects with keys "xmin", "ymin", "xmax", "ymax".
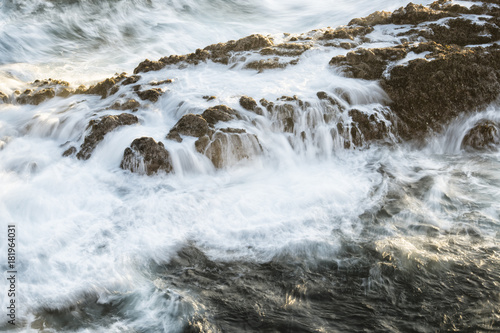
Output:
[{"xmin": 0, "ymin": 0, "xmax": 500, "ymax": 174}]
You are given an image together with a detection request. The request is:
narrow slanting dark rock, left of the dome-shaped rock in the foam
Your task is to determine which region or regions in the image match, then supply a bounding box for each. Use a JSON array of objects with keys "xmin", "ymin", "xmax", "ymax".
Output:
[{"xmin": 76, "ymin": 113, "xmax": 139, "ymax": 160}]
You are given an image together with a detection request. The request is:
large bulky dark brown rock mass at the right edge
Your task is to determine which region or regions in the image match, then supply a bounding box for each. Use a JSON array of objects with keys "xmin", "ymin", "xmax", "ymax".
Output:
[{"xmin": 382, "ymin": 46, "xmax": 500, "ymax": 139}]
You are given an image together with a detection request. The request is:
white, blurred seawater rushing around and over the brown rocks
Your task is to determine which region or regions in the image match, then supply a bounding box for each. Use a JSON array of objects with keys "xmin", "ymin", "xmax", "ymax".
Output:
[{"xmin": 0, "ymin": 0, "xmax": 500, "ymax": 332}]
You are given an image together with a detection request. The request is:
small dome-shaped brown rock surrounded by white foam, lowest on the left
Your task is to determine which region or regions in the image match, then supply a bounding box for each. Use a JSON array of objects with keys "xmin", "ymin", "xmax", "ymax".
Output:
[{"xmin": 120, "ymin": 137, "xmax": 173, "ymax": 176}]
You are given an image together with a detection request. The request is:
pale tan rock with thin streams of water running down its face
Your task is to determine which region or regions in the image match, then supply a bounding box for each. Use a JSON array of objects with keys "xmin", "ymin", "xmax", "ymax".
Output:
[{"xmin": 195, "ymin": 128, "xmax": 262, "ymax": 168}]
